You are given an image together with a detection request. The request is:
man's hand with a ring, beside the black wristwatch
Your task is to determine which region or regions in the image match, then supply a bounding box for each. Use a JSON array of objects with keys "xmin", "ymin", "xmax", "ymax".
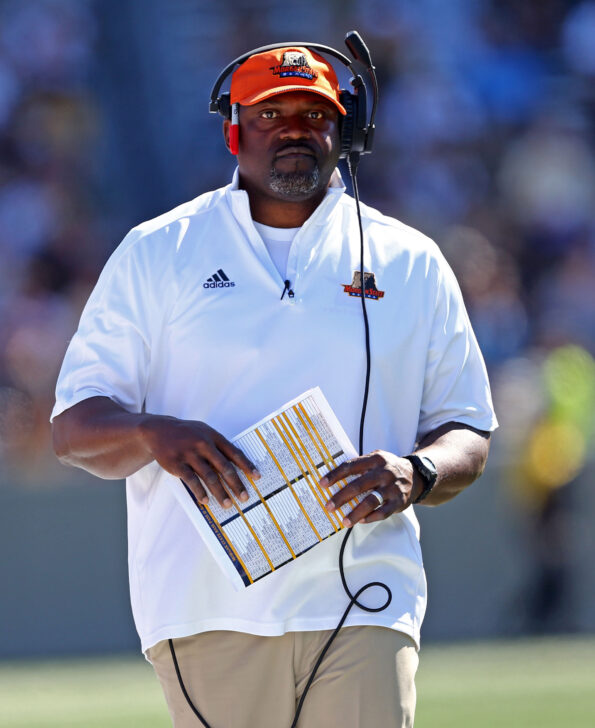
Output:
[{"xmin": 320, "ymin": 450, "xmax": 415, "ymax": 527}]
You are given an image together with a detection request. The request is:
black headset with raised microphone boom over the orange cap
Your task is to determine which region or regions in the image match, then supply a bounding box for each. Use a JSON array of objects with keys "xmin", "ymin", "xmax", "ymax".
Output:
[{"xmin": 209, "ymin": 30, "xmax": 378, "ymax": 163}]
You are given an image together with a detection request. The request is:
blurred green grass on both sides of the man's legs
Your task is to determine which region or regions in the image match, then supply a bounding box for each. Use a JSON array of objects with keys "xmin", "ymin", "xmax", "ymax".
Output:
[{"xmin": 0, "ymin": 637, "xmax": 595, "ymax": 728}]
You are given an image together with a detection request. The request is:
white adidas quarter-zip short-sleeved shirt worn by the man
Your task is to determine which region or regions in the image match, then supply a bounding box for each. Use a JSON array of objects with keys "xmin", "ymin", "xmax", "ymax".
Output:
[{"xmin": 52, "ymin": 172, "xmax": 496, "ymax": 650}]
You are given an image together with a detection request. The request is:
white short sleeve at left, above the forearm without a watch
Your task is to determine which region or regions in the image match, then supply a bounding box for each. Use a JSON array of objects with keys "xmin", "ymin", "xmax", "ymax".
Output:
[{"xmin": 51, "ymin": 230, "xmax": 157, "ymax": 420}]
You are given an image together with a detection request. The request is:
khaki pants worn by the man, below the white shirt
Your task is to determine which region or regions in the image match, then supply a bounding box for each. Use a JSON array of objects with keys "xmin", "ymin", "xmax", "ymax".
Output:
[{"xmin": 147, "ymin": 627, "xmax": 418, "ymax": 728}]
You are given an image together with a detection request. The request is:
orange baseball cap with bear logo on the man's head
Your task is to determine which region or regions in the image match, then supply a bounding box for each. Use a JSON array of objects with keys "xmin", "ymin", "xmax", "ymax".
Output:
[{"xmin": 230, "ymin": 46, "xmax": 347, "ymax": 114}]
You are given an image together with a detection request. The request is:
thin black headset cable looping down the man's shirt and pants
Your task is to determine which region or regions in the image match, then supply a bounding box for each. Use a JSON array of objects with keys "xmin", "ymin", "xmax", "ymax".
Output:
[{"xmin": 169, "ymin": 152, "xmax": 393, "ymax": 728}]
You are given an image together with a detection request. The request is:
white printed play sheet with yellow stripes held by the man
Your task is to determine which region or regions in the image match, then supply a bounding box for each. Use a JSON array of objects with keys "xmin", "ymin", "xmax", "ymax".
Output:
[{"xmin": 171, "ymin": 387, "xmax": 364, "ymax": 588}]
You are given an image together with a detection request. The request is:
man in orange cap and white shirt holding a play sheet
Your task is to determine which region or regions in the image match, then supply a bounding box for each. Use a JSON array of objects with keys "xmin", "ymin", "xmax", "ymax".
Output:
[{"xmin": 53, "ymin": 48, "xmax": 496, "ymax": 728}]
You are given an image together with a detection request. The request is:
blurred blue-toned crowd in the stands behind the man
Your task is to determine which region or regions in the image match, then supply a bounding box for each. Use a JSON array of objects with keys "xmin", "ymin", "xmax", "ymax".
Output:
[{"xmin": 0, "ymin": 0, "xmax": 595, "ymax": 652}]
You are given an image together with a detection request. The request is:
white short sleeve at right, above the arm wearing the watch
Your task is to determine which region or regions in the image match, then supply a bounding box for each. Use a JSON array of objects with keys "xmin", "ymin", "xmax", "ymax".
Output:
[{"xmin": 418, "ymin": 252, "xmax": 498, "ymax": 439}]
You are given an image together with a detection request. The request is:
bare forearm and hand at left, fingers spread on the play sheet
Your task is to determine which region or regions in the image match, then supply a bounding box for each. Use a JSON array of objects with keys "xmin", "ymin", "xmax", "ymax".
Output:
[{"xmin": 52, "ymin": 397, "xmax": 260, "ymax": 508}]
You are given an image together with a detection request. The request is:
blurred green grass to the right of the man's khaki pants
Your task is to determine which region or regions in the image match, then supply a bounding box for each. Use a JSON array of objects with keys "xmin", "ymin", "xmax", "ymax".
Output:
[{"xmin": 415, "ymin": 637, "xmax": 595, "ymax": 728}]
